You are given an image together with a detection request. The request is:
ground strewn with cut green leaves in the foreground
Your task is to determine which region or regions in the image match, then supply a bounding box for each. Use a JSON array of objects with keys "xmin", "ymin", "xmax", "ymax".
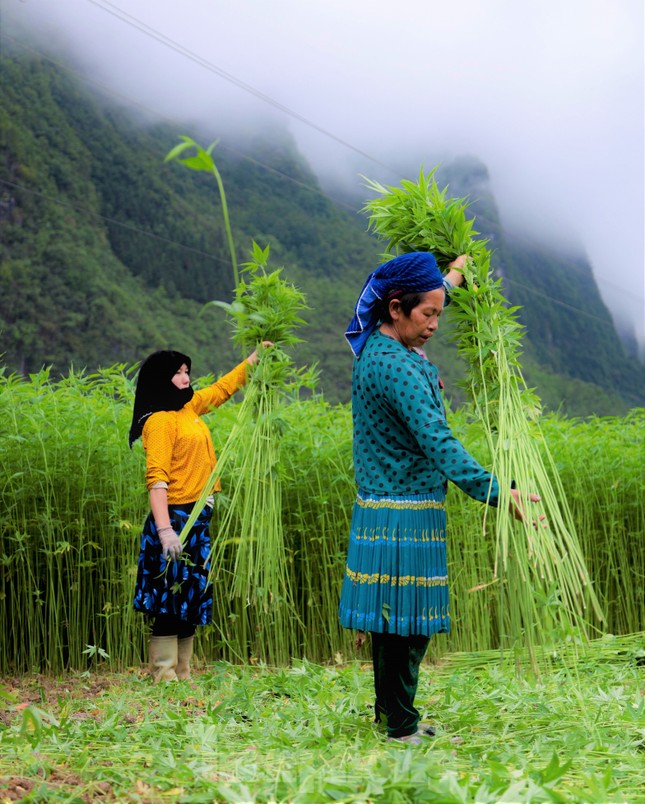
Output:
[{"xmin": 0, "ymin": 634, "xmax": 645, "ymax": 802}]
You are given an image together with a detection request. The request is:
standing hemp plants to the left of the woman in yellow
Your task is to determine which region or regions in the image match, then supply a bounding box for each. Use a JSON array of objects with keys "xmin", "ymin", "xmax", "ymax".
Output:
[{"xmin": 0, "ymin": 366, "xmax": 147, "ymax": 670}]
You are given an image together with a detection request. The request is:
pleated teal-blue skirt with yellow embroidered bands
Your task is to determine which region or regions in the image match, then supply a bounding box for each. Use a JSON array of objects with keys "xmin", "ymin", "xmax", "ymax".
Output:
[{"xmin": 338, "ymin": 489, "xmax": 450, "ymax": 636}]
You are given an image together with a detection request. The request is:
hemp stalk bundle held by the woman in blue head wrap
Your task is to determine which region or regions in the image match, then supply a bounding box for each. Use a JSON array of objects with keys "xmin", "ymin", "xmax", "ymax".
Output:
[{"xmin": 364, "ymin": 168, "xmax": 604, "ymax": 656}]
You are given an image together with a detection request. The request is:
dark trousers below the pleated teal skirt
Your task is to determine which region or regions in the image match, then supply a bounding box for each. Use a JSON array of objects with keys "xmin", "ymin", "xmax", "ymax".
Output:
[{"xmin": 371, "ymin": 632, "xmax": 430, "ymax": 737}]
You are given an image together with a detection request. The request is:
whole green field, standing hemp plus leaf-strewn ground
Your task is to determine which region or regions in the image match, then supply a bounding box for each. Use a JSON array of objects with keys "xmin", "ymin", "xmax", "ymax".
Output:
[{"xmin": 0, "ymin": 366, "xmax": 645, "ymax": 802}]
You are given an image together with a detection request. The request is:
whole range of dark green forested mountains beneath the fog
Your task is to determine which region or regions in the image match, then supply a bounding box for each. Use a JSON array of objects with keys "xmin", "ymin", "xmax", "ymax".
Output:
[{"xmin": 0, "ymin": 49, "xmax": 643, "ymax": 415}]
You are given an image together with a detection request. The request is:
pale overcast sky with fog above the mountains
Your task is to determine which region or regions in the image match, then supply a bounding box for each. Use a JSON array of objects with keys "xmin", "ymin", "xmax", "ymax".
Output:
[{"xmin": 0, "ymin": 0, "xmax": 645, "ymax": 340}]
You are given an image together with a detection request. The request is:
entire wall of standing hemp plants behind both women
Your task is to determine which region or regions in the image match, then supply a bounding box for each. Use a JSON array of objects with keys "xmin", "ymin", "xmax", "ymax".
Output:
[{"xmin": 0, "ymin": 368, "xmax": 645, "ymax": 673}]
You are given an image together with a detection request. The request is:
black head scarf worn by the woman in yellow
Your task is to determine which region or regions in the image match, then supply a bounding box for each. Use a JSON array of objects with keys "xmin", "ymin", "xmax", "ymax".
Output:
[{"xmin": 129, "ymin": 350, "xmax": 195, "ymax": 447}]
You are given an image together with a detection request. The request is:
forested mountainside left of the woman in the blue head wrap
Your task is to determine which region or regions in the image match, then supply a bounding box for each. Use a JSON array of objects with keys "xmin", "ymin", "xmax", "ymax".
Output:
[{"xmin": 0, "ymin": 48, "xmax": 418, "ymax": 400}]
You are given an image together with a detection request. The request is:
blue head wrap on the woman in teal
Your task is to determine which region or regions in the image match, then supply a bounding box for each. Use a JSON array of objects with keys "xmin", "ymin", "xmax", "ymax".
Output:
[{"xmin": 345, "ymin": 251, "xmax": 443, "ymax": 357}]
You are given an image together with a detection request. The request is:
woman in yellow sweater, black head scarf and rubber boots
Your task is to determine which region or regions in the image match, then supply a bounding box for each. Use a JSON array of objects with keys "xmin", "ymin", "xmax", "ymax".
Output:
[{"xmin": 129, "ymin": 342, "xmax": 271, "ymax": 681}]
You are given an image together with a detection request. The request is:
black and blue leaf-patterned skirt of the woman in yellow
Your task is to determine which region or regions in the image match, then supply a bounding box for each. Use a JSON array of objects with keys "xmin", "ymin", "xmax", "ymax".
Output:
[{"xmin": 134, "ymin": 503, "xmax": 213, "ymax": 625}]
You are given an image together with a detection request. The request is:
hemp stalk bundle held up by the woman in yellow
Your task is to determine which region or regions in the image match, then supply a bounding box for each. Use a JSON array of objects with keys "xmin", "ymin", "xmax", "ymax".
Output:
[{"xmin": 174, "ymin": 243, "xmax": 315, "ymax": 665}]
